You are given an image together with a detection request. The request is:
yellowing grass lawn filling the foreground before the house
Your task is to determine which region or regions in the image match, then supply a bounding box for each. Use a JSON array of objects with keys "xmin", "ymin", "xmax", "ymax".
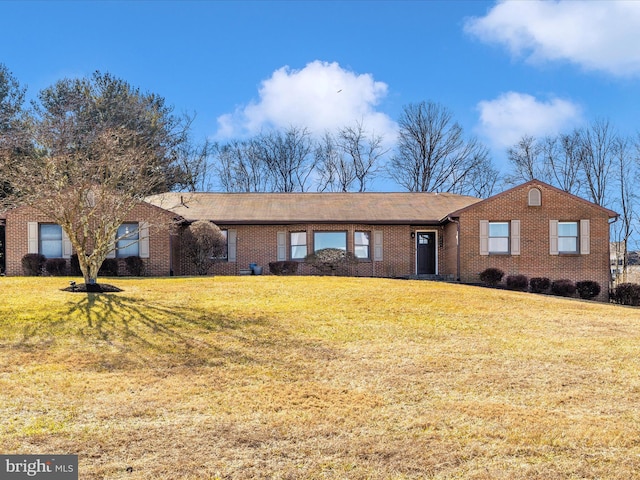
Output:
[{"xmin": 0, "ymin": 277, "xmax": 640, "ymax": 480}]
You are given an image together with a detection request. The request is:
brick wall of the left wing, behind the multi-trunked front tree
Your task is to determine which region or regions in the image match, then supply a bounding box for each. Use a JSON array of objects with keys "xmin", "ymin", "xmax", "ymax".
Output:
[{"xmin": 6, "ymin": 204, "xmax": 172, "ymax": 276}]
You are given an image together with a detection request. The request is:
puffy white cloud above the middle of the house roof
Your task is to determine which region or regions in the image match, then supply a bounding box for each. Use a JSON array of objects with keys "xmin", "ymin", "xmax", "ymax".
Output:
[{"xmin": 216, "ymin": 61, "xmax": 396, "ymax": 142}]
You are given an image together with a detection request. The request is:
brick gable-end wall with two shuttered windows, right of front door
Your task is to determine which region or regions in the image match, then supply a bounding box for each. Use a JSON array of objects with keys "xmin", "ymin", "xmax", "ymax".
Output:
[{"xmin": 460, "ymin": 184, "xmax": 610, "ymax": 300}]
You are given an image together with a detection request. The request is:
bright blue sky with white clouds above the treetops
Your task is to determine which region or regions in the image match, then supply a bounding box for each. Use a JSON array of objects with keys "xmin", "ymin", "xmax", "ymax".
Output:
[{"xmin": 0, "ymin": 0, "xmax": 640, "ymax": 189}]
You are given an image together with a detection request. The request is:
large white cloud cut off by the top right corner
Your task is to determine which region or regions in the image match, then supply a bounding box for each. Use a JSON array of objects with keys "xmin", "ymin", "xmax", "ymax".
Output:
[{"xmin": 465, "ymin": 0, "xmax": 640, "ymax": 76}]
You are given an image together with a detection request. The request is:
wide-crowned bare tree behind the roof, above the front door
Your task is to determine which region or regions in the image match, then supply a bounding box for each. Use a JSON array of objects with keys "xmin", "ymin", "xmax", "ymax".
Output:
[{"xmin": 388, "ymin": 102, "xmax": 488, "ymax": 193}]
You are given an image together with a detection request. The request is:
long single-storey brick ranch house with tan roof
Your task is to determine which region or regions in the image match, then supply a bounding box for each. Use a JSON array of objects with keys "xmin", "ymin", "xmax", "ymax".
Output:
[{"xmin": 4, "ymin": 180, "xmax": 617, "ymax": 300}]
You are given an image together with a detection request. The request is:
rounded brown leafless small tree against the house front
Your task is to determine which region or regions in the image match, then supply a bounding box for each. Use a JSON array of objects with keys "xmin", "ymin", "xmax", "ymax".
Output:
[{"xmin": 182, "ymin": 220, "xmax": 227, "ymax": 275}]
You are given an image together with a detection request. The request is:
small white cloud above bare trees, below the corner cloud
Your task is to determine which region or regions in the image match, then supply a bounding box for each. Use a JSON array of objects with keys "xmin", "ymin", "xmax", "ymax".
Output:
[{"xmin": 478, "ymin": 92, "xmax": 582, "ymax": 148}]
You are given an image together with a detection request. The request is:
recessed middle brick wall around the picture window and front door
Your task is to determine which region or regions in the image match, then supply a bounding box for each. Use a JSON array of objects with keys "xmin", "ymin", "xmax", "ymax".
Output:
[{"xmin": 174, "ymin": 223, "xmax": 446, "ymax": 277}]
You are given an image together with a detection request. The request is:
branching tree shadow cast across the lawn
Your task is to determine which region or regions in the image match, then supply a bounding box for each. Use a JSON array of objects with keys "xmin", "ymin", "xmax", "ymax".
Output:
[{"xmin": 14, "ymin": 294, "xmax": 282, "ymax": 368}]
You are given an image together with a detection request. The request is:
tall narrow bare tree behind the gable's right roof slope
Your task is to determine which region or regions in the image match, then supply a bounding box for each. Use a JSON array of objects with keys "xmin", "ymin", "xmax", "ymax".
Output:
[{"xmin": 580, "ymin": 119, "xmax": 616, "ymax": 206}]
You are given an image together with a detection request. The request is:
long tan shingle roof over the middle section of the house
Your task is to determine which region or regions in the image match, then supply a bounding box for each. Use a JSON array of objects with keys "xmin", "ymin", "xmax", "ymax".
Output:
[{"xmin": 146, "ymin": 192, "xmax": 480, "ymax": 224}]
